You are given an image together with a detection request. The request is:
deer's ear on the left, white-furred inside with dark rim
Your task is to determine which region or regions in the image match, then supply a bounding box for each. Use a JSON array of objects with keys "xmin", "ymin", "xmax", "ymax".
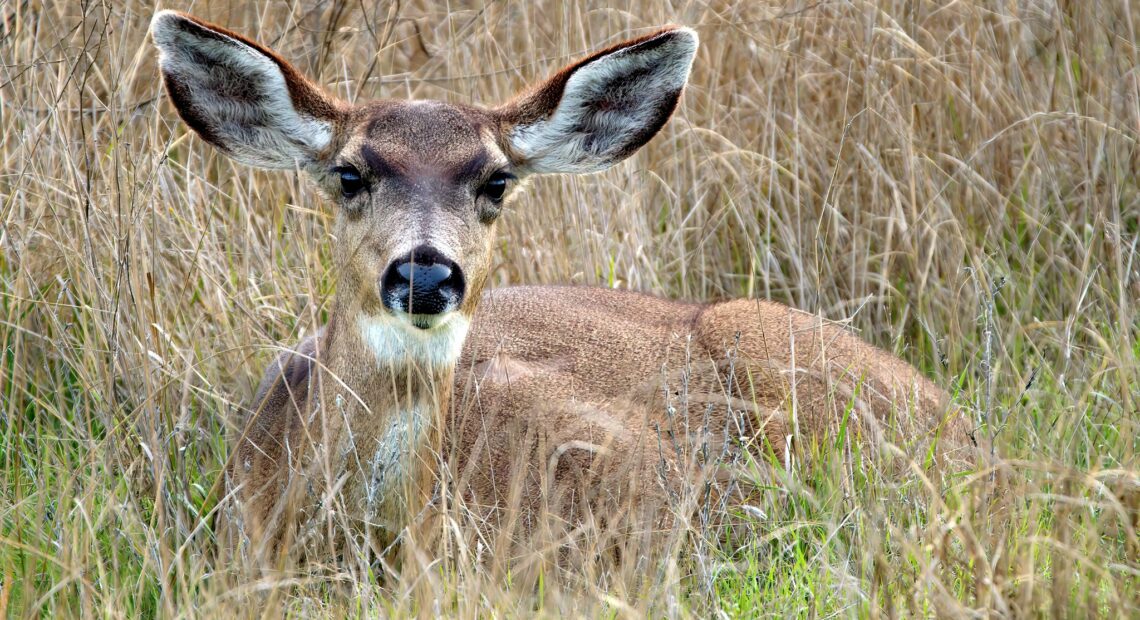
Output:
[{"xmin": 150, "ymin": 10, "xmax": 343, "ymax": 169}]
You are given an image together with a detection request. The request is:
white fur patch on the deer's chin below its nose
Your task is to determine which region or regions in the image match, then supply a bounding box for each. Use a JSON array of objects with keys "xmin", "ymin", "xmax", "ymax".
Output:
[{"xmin": 358, "ymin": 312, "xmax": 471, "ymax": 369}]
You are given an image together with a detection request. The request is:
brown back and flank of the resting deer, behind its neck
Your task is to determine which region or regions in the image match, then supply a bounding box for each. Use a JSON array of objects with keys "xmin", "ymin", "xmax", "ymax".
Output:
[{"xmin": 445, "ymin": 287, "xmax": 972, "ymax": 540}]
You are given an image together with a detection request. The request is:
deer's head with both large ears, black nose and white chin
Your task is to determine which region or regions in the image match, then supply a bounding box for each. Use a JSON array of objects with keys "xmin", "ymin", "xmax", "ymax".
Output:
[{"xmin": 150, "ymin": 10, "xmax": 698, "ymax": 366}]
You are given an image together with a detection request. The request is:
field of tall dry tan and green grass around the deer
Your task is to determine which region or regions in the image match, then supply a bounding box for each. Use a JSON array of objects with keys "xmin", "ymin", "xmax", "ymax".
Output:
[{"xmin": 0, "ymin": 0, "xmax": 1140, "ymax": 618}]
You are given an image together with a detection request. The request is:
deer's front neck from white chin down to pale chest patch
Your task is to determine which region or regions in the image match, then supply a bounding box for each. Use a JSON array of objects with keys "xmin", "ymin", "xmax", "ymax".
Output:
[{"xmin": 319, "ymin": 300, "xmax": 470, "ymax": 532}]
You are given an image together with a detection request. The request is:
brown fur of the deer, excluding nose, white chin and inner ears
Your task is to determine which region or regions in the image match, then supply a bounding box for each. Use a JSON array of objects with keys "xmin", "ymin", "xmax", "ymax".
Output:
[{"xmin": 149, "ymin": 12, "xmax": 969, "ymax": 567}]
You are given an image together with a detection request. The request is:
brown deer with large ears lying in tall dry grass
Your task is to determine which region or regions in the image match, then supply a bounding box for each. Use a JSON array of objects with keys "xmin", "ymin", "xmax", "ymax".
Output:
[{"xmin": 150, "ymin": 10, "xmax": 971, "ymax": 567}]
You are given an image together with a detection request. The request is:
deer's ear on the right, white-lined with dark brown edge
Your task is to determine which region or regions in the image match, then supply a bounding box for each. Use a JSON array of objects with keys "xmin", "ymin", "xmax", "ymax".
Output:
[{"xmin": 496, "ymin": 27, "xmax": 698, "ymax": 173}]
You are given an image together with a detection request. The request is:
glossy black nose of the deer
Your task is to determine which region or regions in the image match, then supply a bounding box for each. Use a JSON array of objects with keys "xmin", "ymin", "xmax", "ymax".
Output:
[{"xmin": 380, "ymin": 245, "xmax": 464, "ymax": 315}]
